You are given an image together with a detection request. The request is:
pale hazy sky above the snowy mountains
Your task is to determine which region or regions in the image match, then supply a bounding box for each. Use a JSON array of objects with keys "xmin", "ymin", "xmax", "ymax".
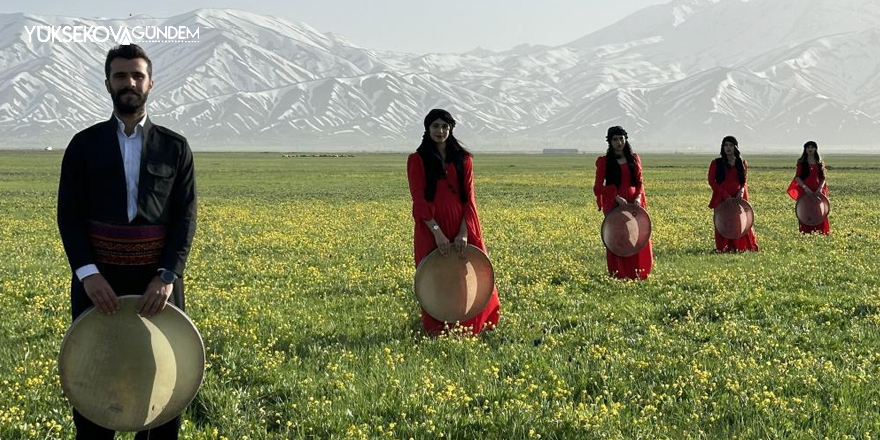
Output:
[{"xmin": 0, "ymin": 0, "xmax": 667, "ymax": 54}]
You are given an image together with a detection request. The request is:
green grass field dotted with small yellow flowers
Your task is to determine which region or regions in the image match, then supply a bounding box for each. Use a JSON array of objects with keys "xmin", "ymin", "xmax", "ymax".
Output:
[{"xmin": 0, "ymin": 152, "xmax": 880, "ymax": 440}]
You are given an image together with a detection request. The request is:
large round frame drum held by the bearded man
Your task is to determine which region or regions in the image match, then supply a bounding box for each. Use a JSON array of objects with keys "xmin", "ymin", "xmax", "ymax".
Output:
[{"xmin": 58, "ymin": 295, "xmax": 205, "ymax": 431}]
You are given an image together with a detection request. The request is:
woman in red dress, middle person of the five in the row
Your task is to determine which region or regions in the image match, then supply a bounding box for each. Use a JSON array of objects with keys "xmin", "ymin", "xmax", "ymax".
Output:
[{"xmin": 593, "ymin": 126, "xmax": 654, "ymax": 280}]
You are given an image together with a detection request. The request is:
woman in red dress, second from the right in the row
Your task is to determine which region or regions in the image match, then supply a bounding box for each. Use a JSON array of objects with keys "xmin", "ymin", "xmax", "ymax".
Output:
[{"xmin": 709, "ymin": 136, "xmax": 758, "ymax": 252}]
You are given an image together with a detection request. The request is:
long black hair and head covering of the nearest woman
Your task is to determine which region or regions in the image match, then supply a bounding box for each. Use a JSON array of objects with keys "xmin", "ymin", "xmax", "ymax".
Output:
[{"xmin": 416, "ymin": 108, "xmax": 473, "ymax": 203}]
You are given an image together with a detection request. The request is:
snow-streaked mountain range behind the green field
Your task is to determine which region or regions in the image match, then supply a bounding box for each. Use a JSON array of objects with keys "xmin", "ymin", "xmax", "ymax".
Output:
[{"xmin": 0, "ymin": 0, "xmax": 880, "ymax": 151}]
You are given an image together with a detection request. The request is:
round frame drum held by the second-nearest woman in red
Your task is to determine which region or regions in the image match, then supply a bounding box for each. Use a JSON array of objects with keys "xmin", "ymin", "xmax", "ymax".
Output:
[{"xmin": 599, "ymin": 205, "xmax": 651, "ymax": 257}]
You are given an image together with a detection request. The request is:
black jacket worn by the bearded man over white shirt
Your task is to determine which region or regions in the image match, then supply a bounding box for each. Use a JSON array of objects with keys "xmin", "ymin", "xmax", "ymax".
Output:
[{"xmin": 58, "ymin": 117, "xmax": 196, "ymax": 276}]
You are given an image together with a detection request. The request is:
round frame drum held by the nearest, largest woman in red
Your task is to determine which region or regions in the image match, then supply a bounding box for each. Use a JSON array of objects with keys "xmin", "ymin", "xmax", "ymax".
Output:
[{"xmin": 414, "ymin": 245, "xmax": 495, "ymax": 322}]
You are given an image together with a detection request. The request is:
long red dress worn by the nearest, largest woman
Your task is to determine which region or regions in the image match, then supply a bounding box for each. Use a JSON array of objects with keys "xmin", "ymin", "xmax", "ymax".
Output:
[{"xmin": 406, "ymin": 153, "xmax": 501, "ymax": 335}]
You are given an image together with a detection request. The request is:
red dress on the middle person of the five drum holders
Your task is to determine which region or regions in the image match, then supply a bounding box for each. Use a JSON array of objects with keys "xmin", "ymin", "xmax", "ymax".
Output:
[{"xmin": 593, "ymin": 154, "xmax": 654, "ymax": 280}]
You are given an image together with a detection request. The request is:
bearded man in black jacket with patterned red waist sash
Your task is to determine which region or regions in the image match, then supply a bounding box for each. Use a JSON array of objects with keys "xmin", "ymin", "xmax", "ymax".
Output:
[{"xmin": 58, "ymin": 44, "xmax": 196, "ymax": 440}]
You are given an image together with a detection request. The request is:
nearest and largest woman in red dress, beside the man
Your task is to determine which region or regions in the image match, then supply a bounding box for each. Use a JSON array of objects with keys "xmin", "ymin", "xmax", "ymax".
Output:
[{"xmin": 406, "ymin": 109, "xmax": 500, "ymax": 335}]
